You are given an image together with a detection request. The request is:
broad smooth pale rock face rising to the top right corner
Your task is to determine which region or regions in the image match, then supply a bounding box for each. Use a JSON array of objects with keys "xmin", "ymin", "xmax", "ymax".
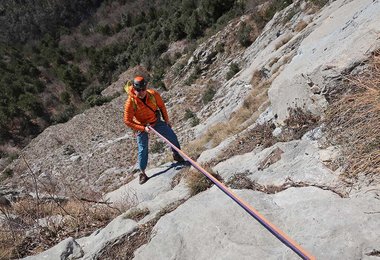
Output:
[{"xmin": 268, "ymin": 0, "xmax": 380, "ymax": 121}]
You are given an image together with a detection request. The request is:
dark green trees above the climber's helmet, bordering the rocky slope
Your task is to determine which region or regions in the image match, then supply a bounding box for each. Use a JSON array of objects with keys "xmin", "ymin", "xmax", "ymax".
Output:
[{"xmin": 82, "ymin": 0, "xmax": 242, "ymax": 84}]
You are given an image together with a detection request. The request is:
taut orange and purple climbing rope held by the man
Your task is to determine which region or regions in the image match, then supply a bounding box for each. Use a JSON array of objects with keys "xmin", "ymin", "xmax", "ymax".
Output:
[{"xmin": 148, "ymin": 126, "xmax": 315, "ymax": 260}]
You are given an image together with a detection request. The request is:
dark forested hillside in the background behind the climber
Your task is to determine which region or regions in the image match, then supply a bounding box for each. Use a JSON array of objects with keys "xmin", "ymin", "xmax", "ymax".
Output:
[{"xmin": 0, "ymin": 0, "xmax": 256, "ymax": 157}]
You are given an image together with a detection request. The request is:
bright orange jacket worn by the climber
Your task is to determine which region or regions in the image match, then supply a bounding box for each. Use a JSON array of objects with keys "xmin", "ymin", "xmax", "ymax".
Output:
[{"xmin": 124, "ymin": 86, "xmax": 169, "ymax": 131}]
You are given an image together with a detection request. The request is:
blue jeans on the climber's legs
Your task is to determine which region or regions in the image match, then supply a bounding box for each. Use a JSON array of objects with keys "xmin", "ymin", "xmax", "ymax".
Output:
[{"xmin": 137, "ymin": 121, "xmax": 181, "ymax": 171}]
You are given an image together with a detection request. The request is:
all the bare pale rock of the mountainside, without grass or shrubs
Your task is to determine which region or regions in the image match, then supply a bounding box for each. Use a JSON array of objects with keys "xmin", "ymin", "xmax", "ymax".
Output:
[{"xmin": 6, "ymin": 0, "xmax": 380, "ymax": 259}]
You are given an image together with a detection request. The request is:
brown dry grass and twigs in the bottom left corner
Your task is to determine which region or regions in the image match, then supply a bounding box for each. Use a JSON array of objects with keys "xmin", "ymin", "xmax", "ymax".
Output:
[{"xmin": 0, "ymin": 193, "xmax": 131, "ymax": 259}]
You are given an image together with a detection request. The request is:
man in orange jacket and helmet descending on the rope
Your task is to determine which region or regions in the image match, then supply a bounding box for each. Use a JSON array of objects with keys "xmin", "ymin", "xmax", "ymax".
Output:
[{"xmin": 124, "ymin": 76, "xmax": 184, "ymax": 184}]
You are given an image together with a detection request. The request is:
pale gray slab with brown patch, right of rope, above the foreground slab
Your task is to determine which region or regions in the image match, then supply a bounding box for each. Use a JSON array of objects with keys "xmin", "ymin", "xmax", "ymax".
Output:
[{"xmin": 213, "ymin": 140, "xmax": 337, "ymax": 186}]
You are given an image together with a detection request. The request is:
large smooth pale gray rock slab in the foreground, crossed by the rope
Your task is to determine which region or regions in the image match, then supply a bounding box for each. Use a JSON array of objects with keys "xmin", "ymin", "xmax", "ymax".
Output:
[{"xmin": 134, "ymin": 187, "xmax": 380, "ymax": 259}]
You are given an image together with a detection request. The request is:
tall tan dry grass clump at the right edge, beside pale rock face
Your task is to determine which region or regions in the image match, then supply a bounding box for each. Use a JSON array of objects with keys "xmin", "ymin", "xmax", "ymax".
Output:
[{"xmin": 326, "ymin": 50, "xmax": 380, "ymax": 178}]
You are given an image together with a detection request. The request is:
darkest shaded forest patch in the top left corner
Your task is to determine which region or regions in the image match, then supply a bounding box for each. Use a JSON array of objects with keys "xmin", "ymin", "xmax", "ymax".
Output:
[{"xmin": 0, "ymin": 0, "xmax": 102, "ymax": 43}]
